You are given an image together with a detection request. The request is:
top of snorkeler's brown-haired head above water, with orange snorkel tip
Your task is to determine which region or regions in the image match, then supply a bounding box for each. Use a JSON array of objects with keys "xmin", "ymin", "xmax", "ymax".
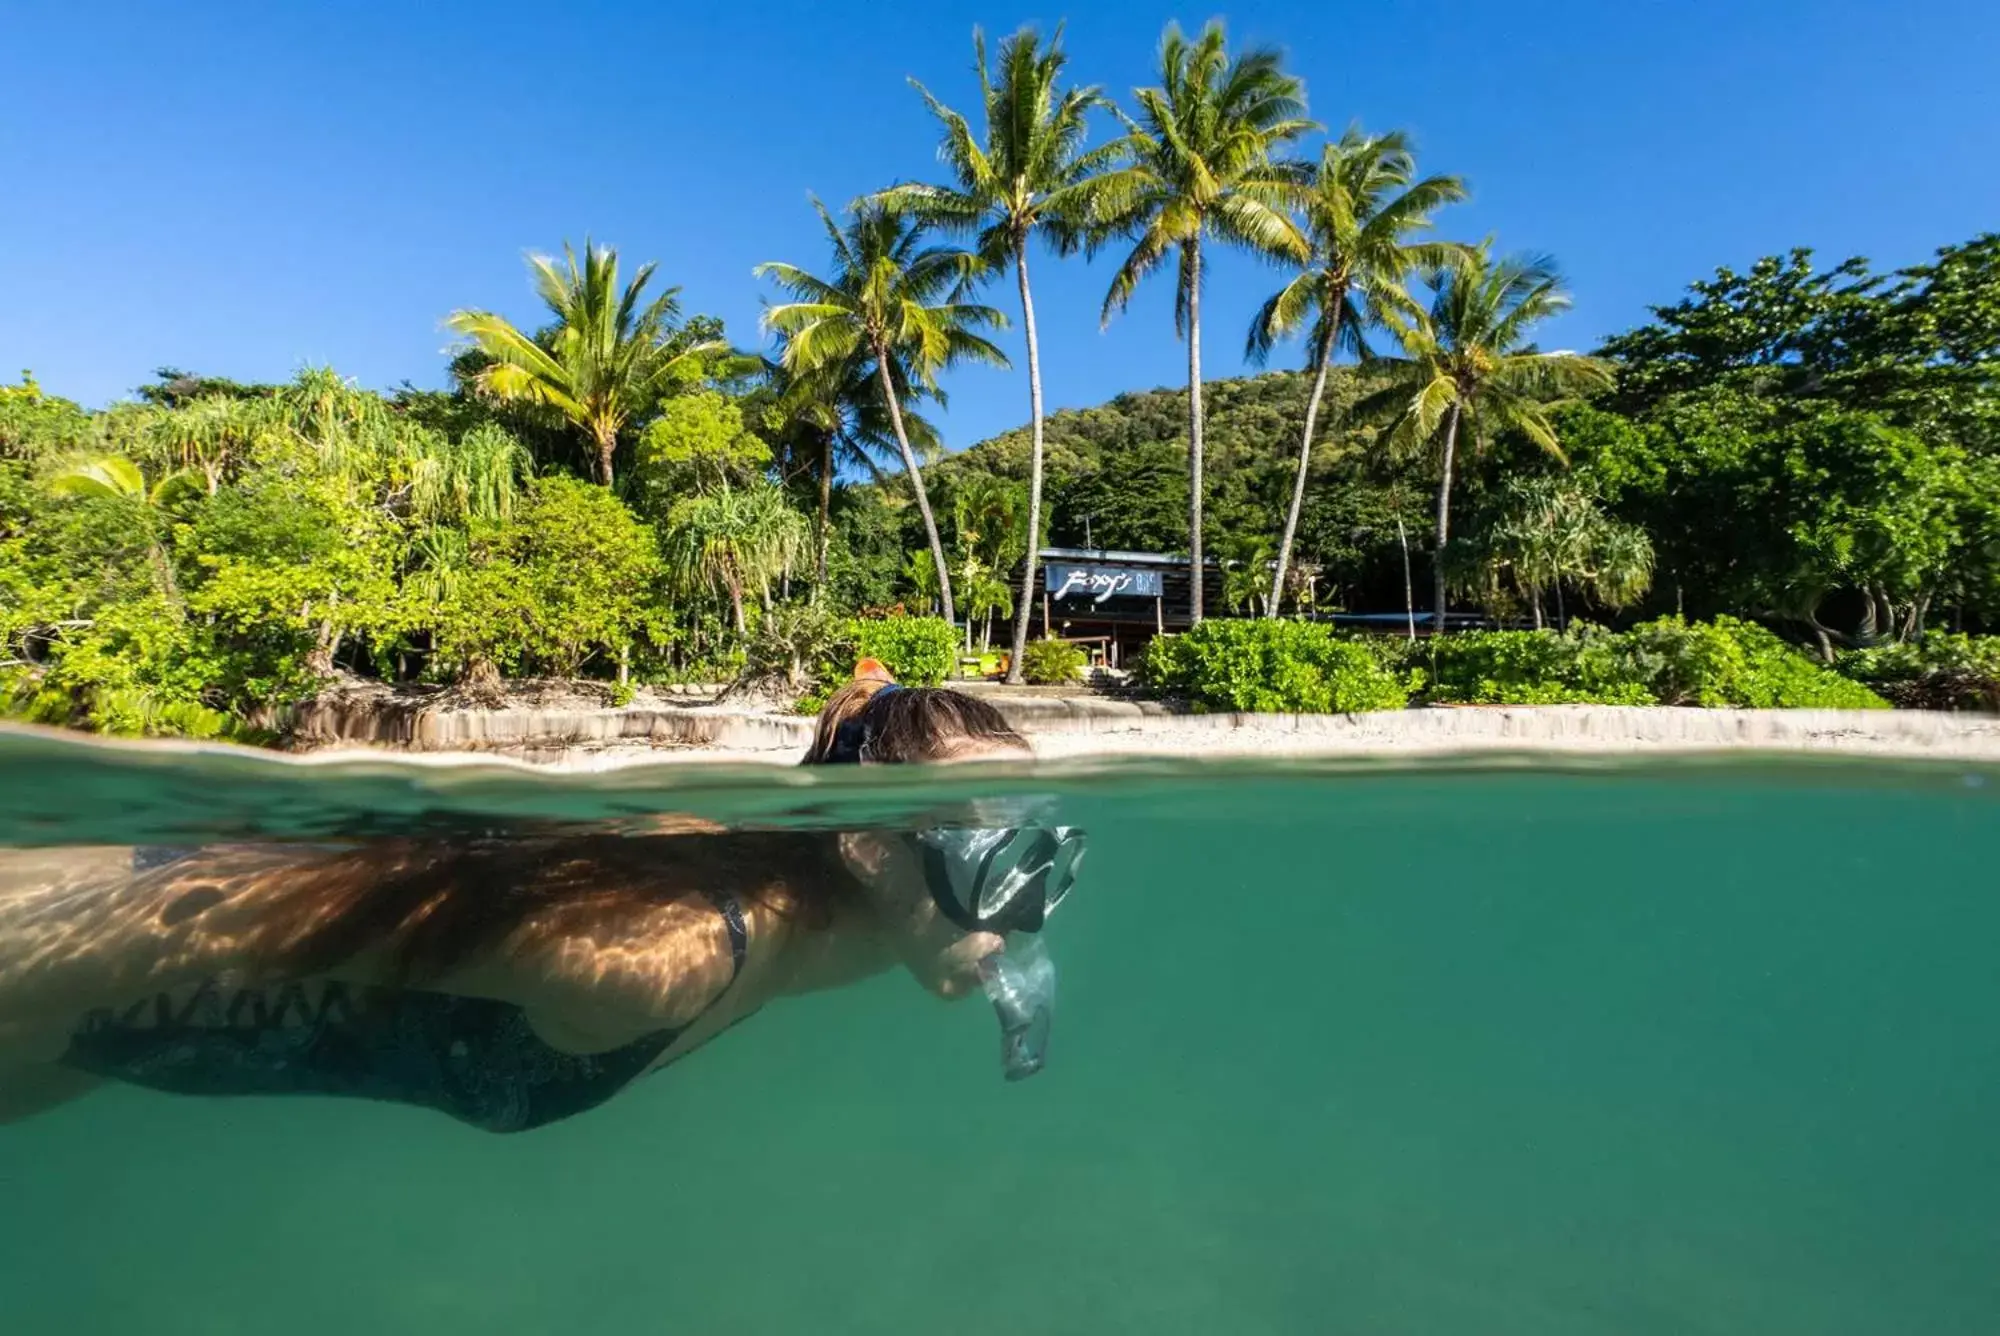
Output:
[{"xmin": 804, "ymin": 658, "xmax": 1030, "ymax": 766}]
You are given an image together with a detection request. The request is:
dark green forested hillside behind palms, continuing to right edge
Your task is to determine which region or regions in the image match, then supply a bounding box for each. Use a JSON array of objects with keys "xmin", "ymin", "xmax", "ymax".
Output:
[{"xmin": 884, "ymin": 234, "xmax": 2000, "ymax": 652}]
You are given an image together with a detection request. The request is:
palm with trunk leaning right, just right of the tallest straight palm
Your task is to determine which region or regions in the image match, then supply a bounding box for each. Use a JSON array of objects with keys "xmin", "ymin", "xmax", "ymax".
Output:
[{"xmin": 1248, "ymin": 128, "xmax": 1466, "ymax": 616}]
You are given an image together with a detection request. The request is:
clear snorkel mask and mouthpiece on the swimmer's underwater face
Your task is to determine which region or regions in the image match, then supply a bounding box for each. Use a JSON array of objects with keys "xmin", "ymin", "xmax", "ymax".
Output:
[{"xmin": 902, "ymin": 826, "xmax": 1084, "ymax": 1080}]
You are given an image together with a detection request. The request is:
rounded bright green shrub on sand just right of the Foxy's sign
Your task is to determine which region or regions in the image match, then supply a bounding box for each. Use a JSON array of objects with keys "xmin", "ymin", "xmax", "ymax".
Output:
[{"xmin": 1140, "ymin": 620, "xmax": 1408, "ymax": 714}]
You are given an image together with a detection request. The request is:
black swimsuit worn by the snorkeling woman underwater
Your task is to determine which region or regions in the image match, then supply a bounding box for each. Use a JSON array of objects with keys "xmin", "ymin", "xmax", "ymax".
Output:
[{"xmin": 62, "ymin": 880, "xmax": 750, "ymax": 1132}]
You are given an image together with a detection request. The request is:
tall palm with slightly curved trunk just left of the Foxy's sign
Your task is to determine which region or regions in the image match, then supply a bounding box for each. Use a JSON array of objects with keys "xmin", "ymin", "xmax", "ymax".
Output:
[{"xmin": 880, "ymin": 26, "xmax": 1120, "ymax": 682}]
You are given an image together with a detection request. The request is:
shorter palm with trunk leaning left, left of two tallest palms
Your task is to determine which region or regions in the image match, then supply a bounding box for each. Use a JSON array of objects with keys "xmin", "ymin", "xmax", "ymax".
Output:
[{"xmin": 756, "ymin": 200, "xmax": 1008, "ymax": 622}]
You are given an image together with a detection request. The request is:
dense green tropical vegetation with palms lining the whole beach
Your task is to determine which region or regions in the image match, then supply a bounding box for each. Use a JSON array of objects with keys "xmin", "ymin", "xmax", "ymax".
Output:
[{"xmin": 0, "ymin": 26, "xmax": 2000, "ymax": 736}]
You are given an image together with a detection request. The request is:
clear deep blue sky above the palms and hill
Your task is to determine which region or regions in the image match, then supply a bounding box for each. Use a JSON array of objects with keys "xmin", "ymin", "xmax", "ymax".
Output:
[{"xmin": 0, "ymin": 0, "xmax": 2000, "ymax": 446}]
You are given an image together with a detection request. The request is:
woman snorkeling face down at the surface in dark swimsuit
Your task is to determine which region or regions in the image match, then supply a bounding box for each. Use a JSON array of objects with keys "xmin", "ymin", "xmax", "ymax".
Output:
[{"xmin": 0, "ymin": 662, "xmax": 1082, "ymax": 1132}]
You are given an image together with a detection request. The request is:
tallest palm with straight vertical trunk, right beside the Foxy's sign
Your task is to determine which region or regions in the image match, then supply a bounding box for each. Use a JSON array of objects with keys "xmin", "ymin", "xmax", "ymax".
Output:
[{"xmin": 1098, "ymin": 22, "xmax": 1314, "ymax": 622}]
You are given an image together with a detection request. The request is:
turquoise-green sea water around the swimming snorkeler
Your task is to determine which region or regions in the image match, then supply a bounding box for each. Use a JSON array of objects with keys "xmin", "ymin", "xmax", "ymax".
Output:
[{"xmin": 0, "ymin": 742, "xmax": 2000, "ymax": 1336}]
